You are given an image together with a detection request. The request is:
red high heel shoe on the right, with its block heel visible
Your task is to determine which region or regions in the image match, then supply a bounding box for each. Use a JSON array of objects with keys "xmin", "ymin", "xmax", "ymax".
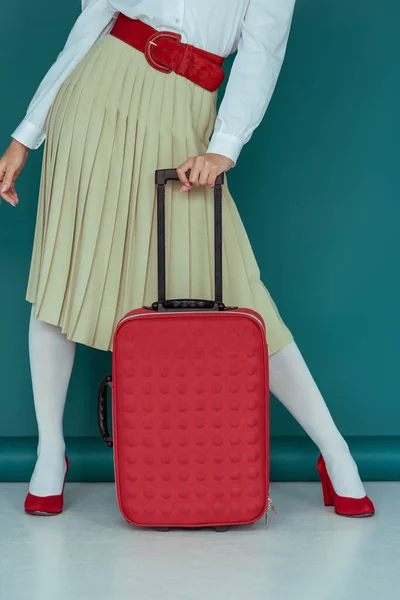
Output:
[{"xmin": 317, "ymin": 455, "xmax": 375, "ymax": 517}]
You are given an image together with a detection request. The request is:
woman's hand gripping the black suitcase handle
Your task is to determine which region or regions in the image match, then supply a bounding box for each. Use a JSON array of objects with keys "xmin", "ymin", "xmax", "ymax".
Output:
[{"xmin": 177, "ymin": 153, "xmax": 234, "ymax": 192}]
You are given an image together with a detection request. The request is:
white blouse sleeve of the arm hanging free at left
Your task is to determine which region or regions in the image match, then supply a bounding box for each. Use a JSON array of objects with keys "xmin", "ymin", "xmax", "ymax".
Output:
[{"xmin": 12, "ymin": 0, "xmax": 115, "ymax": 149}]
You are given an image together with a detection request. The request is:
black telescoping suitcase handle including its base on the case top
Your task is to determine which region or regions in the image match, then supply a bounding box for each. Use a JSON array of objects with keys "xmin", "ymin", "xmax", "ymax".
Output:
[{"xmin": 152, "ymin": 169, "xmax": 225, "ymax": 312}]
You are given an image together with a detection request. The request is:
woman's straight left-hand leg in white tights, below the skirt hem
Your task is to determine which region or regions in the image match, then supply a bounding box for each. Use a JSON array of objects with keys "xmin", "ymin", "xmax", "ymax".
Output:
[{"xmin": 29, "ymin": 307, "xmax": 75, "ymax": 496}]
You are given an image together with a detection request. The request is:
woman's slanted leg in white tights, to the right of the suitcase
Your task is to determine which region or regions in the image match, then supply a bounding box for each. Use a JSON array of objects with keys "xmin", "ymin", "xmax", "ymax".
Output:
[{"xmin": 270, "ymin": 342, "xmax": 366, "ymax": 498}]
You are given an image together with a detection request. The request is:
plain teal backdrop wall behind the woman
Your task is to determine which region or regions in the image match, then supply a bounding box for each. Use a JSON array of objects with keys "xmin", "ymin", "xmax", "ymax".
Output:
[{"xmin": 0, "ymin": 0, "xmax": 400, "ymax": 480}]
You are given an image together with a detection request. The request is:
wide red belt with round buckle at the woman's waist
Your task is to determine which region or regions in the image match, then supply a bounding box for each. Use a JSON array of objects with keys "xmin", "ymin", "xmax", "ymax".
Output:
[{"xmin": 111, "ymin": 13, "xmax": 225, "ymax": 92}]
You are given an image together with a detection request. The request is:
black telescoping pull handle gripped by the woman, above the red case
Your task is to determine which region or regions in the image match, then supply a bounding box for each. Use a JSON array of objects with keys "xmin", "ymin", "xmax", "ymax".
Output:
[{"xmin": 155, "ymin": 169, "xmax": 225, "ymax": 304}]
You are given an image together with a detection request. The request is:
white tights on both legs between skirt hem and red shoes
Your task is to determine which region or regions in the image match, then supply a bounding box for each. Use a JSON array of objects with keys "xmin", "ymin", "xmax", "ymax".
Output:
[{"xmin": 29, "ymin": 309, "xmax": 365, "ymax": 498}]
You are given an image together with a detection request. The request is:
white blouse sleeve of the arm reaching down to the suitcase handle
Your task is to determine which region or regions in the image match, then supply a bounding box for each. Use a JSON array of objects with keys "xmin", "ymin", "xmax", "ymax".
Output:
[{"xmin": 208, "ymin": 0, "xmax": 296, "ymax": 164}]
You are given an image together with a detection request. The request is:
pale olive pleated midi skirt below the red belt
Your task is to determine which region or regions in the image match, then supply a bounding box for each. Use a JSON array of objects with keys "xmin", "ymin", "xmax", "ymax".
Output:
[{"xmin": 27, "ymin": 35, "xmax": 292, "ymax": 354}]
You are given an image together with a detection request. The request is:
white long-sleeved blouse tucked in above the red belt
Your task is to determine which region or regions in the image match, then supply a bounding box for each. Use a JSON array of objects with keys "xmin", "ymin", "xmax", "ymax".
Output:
[{"xmin": 13, "ymin": 0, "xmax": 295, "ymax": 163}]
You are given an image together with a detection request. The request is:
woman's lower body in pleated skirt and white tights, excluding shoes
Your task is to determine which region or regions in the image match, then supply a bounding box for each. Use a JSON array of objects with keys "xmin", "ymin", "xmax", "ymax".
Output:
[{"xmin": 27, "ymin": 36, "xmax": 365, "ymax": 506}]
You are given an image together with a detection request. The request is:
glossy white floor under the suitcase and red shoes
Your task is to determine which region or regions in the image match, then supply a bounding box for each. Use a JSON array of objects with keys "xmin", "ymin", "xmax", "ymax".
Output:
[{"xmin": 0, "ymin": 483, "xmax": 400, "ymax": 600}]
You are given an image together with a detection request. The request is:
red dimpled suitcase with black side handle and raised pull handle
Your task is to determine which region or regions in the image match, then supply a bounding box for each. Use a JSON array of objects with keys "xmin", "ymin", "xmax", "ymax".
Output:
[{"xmin": 98, "ymin": 169, "xmax": 269, "ymax": 530}]
